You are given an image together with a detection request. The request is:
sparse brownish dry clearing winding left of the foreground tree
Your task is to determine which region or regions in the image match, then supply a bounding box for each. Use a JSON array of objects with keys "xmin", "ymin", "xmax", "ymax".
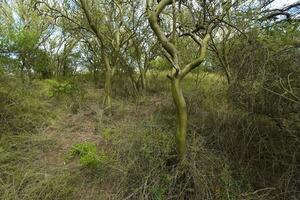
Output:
[{"xmin": 32, "ymin": 89, "xmax": 168, "ymax": 200}]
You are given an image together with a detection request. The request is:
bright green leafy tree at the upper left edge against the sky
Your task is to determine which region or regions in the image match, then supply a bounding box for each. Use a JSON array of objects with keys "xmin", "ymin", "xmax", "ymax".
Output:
[{"xmin": 0, "ymin": 1, "xmax": 52, "ymax": 81}]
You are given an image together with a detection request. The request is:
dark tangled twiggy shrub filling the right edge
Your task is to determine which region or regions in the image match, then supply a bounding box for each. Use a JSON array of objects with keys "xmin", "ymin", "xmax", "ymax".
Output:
[{"xmin": 226, "ymin": 28, "xmax": 300, "ymax": 196}]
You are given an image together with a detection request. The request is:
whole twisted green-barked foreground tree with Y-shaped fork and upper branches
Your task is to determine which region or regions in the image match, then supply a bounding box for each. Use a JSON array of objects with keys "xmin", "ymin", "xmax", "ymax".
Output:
[{"xmin": 146, "ymin": 0, "xmax": 219, "ymax": 161}]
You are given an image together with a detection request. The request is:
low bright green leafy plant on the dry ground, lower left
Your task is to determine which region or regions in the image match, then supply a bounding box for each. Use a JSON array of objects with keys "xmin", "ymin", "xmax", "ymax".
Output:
[{"xmin": 69, "ymin": 142, "xmax": 108, "ymax": 168}]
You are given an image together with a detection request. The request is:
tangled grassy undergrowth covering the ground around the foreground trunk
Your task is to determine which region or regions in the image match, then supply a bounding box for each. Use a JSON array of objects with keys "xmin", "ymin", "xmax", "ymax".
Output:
[{"xmin": 0, "ymin": 74, "xmax": 300, "ymax": 200}]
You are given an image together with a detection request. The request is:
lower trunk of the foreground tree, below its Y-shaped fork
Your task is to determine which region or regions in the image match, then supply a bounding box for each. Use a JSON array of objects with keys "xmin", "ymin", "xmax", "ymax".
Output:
[{"xmin": 171, "ymin": 77, "xmax": 188, "ymax": 161}]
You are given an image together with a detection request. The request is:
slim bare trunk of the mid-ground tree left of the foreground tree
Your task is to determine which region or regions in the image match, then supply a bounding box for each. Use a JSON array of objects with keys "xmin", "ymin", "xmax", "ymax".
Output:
[{"xmin": 104, "ymin": 55, "xmax": 112, "ymax": 109}]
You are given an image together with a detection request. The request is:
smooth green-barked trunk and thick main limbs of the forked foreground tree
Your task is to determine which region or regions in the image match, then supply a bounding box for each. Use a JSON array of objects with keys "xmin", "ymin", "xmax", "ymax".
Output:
[{"xmin": 146, "ymin": 0, "xmax": 214, "ymax": 161}]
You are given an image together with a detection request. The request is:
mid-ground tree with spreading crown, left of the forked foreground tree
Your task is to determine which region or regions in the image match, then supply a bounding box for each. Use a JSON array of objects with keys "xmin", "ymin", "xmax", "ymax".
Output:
[{"xmin": 38, "ymin": 0, "xmax": 144, "ymax": 109}]
